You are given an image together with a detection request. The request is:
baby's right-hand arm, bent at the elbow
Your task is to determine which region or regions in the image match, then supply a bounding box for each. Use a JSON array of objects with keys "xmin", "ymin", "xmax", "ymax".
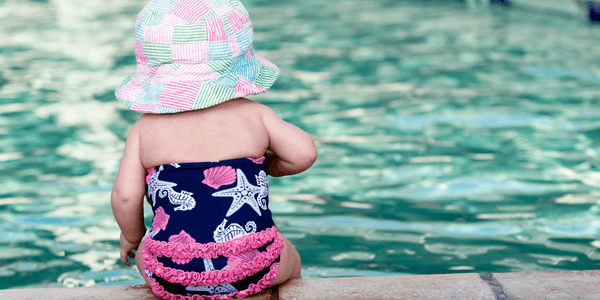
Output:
[{"xmin": 261, "ymin": 106, "xmax": 317, "ymax": 177}]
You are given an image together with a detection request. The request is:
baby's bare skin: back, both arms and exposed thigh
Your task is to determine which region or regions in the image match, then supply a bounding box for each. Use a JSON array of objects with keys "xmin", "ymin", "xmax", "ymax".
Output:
[{"xmin": 111, "ymin": 98, "xmax": 317, "ymax": 286}]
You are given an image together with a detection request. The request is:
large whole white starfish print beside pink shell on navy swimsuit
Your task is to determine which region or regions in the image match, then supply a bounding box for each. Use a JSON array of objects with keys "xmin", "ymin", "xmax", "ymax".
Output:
[{"xmin": 212, "ymin": 169, "xmax": 262, "ymax": 217}]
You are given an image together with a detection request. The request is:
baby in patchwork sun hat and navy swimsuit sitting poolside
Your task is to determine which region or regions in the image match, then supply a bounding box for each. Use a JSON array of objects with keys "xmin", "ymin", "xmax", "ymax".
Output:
[{"xmin": 111, "ymin": 0, "xmax": 317, "ymax": 299}]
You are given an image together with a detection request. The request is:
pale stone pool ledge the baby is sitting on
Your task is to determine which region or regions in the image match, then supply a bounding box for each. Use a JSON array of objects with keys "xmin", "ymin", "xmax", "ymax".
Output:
[{"xmin": 0, "ymin": 270, "xmax": 600, "ymax": 300}]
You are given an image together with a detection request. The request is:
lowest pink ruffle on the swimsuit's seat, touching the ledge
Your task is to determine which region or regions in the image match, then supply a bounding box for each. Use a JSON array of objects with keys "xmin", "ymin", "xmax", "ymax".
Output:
[{"xmin": 148, "ymin": 263, "xmax": 279, "ymax": 300}]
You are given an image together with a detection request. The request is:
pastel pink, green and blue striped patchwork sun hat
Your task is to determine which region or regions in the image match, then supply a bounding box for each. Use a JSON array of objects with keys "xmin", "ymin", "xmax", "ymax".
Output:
[{"xmin": 115, "ymin": 0, "xmax": 279, "ymax": 113}]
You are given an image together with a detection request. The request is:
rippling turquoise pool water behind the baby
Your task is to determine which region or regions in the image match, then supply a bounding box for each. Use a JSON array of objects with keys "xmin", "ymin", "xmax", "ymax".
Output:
[{"xmin": 0, "ymin": 0, "xmax": 600, "ymax": 289}]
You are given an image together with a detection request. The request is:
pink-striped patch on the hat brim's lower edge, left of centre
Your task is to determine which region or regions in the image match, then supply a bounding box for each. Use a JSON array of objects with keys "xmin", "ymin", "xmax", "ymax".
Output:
[{"xmin": 158, "ymin": 82, "xmax": 202, "ymax": 110}]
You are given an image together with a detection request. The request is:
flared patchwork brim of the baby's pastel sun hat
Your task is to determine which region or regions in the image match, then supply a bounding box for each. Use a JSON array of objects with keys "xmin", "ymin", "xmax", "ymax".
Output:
[{"xmin": 115, "ymin": 48, "xmax": 279, "ymax": 114}]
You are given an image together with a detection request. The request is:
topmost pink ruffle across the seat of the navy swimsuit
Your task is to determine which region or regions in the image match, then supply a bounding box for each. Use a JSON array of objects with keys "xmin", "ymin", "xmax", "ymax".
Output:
[{"xmin": 145, "ymin": 226, "xmax": 277, "ymax": 259}]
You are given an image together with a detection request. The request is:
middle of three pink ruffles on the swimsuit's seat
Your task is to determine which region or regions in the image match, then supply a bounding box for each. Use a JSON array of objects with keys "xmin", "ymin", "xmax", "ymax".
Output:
[{"xmin": 142, "ymin": 236, "xmax": 283, "ymax": 286}]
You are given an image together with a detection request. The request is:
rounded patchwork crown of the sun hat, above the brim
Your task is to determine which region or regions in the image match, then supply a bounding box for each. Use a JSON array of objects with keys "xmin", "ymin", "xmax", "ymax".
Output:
[{"xmin": 135, "ymin": 0, "xmax": 253, "ymax": 67}]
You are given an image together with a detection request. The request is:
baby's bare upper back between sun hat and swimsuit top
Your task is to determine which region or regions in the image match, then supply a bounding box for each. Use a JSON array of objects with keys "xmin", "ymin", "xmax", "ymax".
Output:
[{"xmin": 134, "ymin": 99, "xmax": 269, "ymax": 168}]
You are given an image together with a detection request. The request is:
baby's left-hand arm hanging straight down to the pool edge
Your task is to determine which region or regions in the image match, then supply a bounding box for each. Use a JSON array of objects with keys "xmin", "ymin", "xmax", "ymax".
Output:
[{"xmin": 111, "ymin": 125, "xmax": 146, "ymax": 266}]
